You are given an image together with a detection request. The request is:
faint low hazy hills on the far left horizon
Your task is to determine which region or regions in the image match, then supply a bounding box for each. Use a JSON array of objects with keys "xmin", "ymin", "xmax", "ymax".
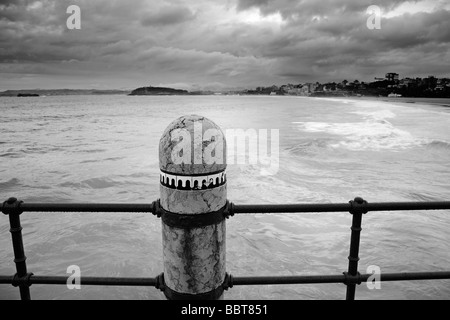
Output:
[{"xmin": 0, "ymin": 89, "xmax": 130, "ymax": 97}]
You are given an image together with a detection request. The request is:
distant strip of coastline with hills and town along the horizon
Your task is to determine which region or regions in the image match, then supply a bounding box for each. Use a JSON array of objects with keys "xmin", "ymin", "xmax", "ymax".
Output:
[{"xmin": 0, "ymin": 72, "xmax": 450, "ymax": 98}]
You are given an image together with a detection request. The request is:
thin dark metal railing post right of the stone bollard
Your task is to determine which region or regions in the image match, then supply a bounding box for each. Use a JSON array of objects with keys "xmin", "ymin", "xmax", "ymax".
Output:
[{"xmin": 346, "ymin": 197, "xmax": 367, "ymax": 300}]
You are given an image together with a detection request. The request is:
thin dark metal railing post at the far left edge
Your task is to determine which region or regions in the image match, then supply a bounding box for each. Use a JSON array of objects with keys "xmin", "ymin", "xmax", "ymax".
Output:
[{"xmin": 2, "ymin": 198, "xmax": 31, "ymax": 300}]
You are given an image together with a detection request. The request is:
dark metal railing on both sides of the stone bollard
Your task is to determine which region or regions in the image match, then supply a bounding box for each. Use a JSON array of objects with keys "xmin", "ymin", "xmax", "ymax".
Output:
[{"xmin": 0, "ymin": 198, "xmax": 450, "ymax": 300}]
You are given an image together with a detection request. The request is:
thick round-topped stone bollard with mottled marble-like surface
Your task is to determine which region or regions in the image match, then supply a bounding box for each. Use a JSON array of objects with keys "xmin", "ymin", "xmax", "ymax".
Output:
[{"xmin": 157, "ymin": 116, "xmax": 227, "ymax": 300}]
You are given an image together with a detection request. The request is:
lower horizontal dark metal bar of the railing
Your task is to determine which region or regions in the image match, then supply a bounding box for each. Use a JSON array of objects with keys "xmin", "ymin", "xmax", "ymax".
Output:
[{"xmin": 0, "ymin": 271, "xmax": 450, "ymax": 287}]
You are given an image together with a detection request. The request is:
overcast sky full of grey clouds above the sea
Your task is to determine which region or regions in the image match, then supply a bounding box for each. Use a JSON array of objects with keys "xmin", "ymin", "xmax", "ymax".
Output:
[{"xmin": 0, "ymin": 0, "xmax": 450, "ymax": 91}]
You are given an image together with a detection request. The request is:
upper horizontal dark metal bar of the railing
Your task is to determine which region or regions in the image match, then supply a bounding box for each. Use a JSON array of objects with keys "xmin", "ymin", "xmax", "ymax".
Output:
[{"xmin": 11, "ymin": 201, "xmax": 450, "ymax": 214}]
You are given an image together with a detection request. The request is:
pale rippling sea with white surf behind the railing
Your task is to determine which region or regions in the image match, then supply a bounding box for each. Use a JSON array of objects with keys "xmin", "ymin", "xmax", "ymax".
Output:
[{"xmin": 0, "ymin": 95, "xmax": 450, "ymax": 300}]
